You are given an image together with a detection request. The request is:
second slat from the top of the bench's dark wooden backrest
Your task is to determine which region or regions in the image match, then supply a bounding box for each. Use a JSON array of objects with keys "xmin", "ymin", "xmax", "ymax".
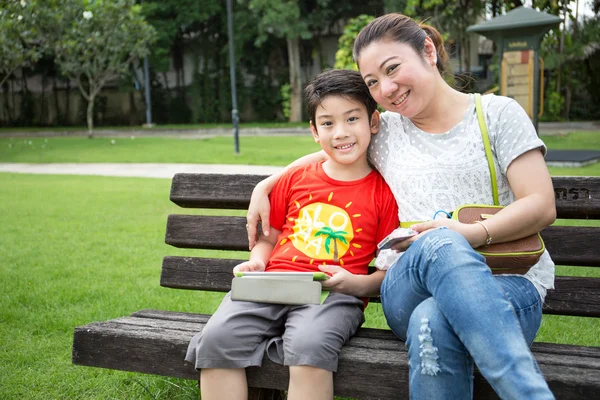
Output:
[{"xmin": 165, "ymin": 215, "xmax": 600, "ymax": 267}]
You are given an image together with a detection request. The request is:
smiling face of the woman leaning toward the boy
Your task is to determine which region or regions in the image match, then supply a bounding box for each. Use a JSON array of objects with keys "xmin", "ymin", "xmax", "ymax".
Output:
[{"xmin": 358, "ymin": 38, "xmax": 436, "ymax": 118}]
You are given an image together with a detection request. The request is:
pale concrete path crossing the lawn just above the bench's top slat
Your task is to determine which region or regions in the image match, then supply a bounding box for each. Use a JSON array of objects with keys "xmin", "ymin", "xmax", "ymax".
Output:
[{"xmin": 0, "ymin": 163, "xmax": 283, "ymax": 179}]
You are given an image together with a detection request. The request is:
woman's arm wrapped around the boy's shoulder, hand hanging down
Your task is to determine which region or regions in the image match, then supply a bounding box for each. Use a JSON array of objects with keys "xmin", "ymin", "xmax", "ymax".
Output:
[{"xmin": 246, "ymin": 150, "xmax": 327, "ymax": 250}]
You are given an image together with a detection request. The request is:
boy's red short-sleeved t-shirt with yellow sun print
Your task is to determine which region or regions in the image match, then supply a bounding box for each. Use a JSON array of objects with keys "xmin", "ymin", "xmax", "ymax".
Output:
[{"xmin": 266, "ymin": 163, "xmax": 398, "ymax": 275}]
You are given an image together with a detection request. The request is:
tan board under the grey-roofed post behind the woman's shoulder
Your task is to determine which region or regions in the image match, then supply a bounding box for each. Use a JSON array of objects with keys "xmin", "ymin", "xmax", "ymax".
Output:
[{"xmin": 500, "ymin": 50, "xmax": 535, "ymax": 118}]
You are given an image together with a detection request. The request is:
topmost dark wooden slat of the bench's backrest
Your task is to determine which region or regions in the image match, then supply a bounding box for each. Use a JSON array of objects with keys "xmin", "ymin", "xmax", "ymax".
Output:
[{"xmin": 171, "ymin": 174, "xmax": 600, "ymax": 219}]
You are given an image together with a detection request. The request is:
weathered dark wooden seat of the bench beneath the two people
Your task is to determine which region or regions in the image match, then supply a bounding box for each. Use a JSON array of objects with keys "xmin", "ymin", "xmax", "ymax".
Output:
[{"xmin": 73, "ymin": 310, "xmax": 600, "ymax": 399}]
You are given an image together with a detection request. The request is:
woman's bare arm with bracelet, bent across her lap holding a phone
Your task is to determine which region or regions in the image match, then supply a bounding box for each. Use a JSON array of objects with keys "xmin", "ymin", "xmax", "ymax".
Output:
[{"xmin": 406, "ymin": 149, "xmax": 556, "ymax": 251}]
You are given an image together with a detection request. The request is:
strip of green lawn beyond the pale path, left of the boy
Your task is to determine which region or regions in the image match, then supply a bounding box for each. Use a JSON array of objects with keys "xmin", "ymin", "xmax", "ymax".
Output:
[{"xmin": 0, "ymin": 136, "xmax": 320, "ymax": 165}]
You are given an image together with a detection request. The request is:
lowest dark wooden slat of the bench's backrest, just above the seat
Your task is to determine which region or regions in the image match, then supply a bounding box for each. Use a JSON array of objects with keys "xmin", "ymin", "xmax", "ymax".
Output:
[{"xmin": 160, "ymin": 257, "xmax": 600, "ymax": 317}]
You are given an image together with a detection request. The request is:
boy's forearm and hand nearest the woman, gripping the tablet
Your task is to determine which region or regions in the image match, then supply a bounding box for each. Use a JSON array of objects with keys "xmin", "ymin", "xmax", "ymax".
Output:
[{"xmin": 319, "ymin": 265, "xmax": 385, "ymax": 297}]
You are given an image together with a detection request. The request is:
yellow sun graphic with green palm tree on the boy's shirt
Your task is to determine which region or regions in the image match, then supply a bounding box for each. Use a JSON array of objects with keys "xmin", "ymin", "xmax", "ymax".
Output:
[{"xmin": 280, "ymin": 192, "xmax": 362, "ymax": 265}]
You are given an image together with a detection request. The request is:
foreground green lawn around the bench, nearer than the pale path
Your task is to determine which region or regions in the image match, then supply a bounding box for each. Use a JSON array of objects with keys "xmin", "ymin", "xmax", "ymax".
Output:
[{"xmin": 0, "ymin": 174, "xmax": 600, "ymax": 399}]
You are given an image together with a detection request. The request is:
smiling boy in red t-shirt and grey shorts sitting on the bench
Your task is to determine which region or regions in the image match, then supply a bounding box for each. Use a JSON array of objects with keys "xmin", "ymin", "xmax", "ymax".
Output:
[{"xmin": 186, "ymin": 70, "xmax": 398, "ymax": 400}]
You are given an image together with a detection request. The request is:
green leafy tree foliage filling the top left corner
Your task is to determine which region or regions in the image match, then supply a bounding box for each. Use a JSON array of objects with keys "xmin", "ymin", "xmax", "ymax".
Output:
[{"xmin": 0, "ymin": 0, "xmax": 46, "ymax": 87}]
